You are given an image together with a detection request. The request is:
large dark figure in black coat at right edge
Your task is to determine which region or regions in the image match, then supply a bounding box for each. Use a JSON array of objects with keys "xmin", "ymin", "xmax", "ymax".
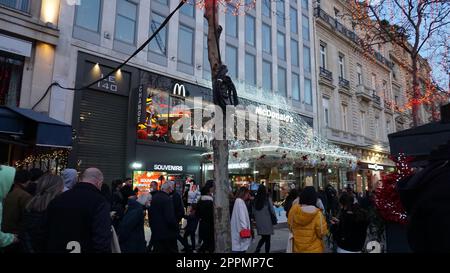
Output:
[{"xmin": 397, "ymin": 159, "xmax": 450, "ymax": 253}]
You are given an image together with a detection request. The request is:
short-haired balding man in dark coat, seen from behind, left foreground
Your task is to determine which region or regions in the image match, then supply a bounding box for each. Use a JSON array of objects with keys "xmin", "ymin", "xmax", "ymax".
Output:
[{"xmin": 46, "ymin": 168, "xmax": 112, "ymax": 253}]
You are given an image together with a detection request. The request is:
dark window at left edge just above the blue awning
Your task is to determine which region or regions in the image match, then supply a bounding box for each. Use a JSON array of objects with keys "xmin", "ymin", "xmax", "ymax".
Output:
[{"xmin": 0, "ymin": 54, "xmax": 24, "ymax": 107}]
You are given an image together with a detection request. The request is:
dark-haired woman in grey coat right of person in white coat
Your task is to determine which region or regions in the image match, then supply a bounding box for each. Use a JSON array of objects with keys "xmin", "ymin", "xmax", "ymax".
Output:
[{"xmin": 253, "ymin": 185, "xmax": 277, "ymax": 253}]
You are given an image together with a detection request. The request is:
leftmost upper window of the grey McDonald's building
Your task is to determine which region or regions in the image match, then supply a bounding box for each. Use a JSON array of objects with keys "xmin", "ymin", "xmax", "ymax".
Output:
[{"xmin": 74, "ymin": 0, "xmax": 101, "ymax": 32}]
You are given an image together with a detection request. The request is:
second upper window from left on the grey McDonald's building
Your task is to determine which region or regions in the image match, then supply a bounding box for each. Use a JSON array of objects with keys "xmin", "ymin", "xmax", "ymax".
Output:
[{"xmin": 115, "ymin": 0, "xmax": 137, "ymax": 45}]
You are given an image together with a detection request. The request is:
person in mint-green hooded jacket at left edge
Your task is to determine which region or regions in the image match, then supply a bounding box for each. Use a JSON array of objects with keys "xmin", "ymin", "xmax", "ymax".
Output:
[{"xmin": 0, "ymin": 165, "xmax": 19, "ymax": 249}]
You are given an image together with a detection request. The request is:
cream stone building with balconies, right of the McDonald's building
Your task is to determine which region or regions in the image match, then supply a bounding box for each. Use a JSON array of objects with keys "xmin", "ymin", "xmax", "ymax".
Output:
[{"xmin": 315, "ymin": 0, "xmax": 400, "ymax": 191}]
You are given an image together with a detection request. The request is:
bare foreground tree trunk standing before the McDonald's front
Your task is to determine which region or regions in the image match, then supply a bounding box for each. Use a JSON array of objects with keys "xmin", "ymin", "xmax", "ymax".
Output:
[{"xmin": 204, "ymin": 0, "xmax": 231, "ymax": 253}]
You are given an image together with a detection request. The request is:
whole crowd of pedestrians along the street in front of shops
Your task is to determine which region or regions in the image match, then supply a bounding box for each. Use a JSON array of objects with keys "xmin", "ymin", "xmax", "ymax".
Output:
[{"xmin": 0, "ymin": 162, "xmax": 376, "ymax": 253}]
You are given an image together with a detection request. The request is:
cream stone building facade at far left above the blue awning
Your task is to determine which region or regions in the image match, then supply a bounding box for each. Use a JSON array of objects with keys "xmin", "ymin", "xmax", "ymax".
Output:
[{"xmin": 0, "ymin": 0, "xmax": 60, "ymax": 113}]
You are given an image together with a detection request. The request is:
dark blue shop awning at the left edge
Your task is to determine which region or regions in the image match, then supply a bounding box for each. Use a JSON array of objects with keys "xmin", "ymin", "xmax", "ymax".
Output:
[{"xmin": 0, "ymin": 106, "xmax": 72, "ymax": 148}]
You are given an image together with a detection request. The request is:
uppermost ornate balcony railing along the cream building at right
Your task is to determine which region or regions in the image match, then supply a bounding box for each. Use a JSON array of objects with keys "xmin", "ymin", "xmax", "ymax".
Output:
[{"xmin": 314, "ymin": 7, "xmax": 394, "ymax": 68}]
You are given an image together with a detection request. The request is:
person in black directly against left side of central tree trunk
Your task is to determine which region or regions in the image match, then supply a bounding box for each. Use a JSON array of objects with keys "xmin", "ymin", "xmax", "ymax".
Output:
[{"xmin": 197, "ymin": 180, "xmax": 215, "ymax": 253}]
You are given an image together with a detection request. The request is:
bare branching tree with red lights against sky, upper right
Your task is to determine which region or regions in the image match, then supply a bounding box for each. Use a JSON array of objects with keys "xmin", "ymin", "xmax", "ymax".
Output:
[{"xmin": 348, "ymin": 0, "xmax": 450, "ymax": 126}]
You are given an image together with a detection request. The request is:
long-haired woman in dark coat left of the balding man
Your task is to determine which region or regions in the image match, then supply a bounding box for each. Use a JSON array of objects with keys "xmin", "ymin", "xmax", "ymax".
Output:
[{"xmin": 21, "ymin": 174, "xmax": 64, "ymax": 253}]
